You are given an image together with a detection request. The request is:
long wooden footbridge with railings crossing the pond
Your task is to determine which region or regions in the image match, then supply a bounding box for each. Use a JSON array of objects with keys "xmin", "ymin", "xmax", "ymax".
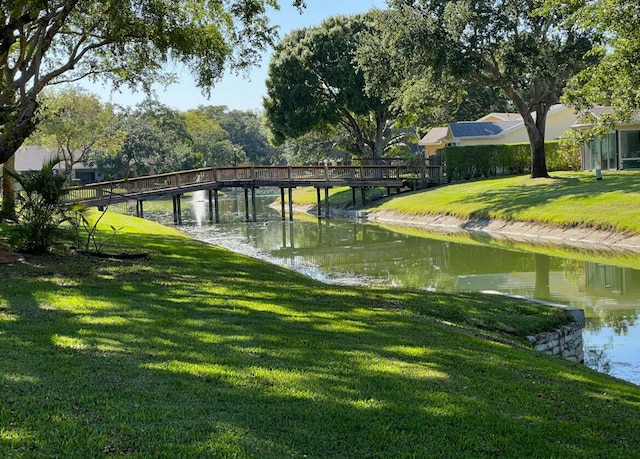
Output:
[{"xmin": 70, "ymin": 164, "xmax": 442, "ymax": 224}]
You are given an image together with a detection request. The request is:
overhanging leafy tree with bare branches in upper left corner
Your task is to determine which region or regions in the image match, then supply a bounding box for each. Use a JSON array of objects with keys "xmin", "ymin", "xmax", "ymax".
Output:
[{"xmin": 0, "ymin": 0, "xmax": 304, "ymax": 164}]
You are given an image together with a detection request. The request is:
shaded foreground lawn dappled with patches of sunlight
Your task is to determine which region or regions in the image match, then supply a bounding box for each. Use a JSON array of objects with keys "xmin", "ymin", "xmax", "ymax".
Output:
[{"xmin": 0, "ymin": 214, "xmax": 640, "ymax": 458}]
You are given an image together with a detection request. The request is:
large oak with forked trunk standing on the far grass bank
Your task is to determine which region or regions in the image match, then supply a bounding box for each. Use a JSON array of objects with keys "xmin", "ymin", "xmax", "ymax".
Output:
[{"xmin": 390, "ymin": 0, "xmax": 597, "ymax": 178}]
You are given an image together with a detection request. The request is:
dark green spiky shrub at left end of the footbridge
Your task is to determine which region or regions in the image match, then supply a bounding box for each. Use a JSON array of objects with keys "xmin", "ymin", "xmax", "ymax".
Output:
[{"xmin": 6, "ymin": 158, "xmax": 70, "ymax": 253}]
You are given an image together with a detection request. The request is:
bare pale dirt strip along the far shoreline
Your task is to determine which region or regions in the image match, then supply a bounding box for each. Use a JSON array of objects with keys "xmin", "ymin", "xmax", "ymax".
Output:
[{"xmin": 367, "ymin": 211, "xmax": 640, "ymax": 253}]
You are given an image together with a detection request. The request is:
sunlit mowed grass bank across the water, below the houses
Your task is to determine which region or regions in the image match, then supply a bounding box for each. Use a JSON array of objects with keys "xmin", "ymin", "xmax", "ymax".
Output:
[{"xmin": 371, "ymin": 171, "xmax": 640, "ymax": 233}]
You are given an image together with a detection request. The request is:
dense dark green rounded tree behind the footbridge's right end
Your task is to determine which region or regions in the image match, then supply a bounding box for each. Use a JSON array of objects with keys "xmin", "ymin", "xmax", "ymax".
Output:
[{"xmin": 264, "ymin": 11, "xmax": 410, "ymax": 158}]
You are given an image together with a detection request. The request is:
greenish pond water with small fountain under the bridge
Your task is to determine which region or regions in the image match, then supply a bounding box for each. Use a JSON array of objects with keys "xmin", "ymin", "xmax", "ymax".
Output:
[{"xmin": 135, "ymin": 193, "xmax": 640, "ymax": 384}]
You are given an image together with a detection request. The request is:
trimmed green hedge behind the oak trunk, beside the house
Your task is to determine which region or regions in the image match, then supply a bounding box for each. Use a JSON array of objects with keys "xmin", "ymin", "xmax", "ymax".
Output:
[{"xmin": 440, "ymin": 141, "xmax": 580, "ymax": 182}]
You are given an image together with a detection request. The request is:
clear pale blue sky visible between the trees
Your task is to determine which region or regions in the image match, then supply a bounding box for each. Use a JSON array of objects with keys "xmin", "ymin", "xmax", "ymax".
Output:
[{"xmin": 82, "ymin": 0, "xmax": 386, "ymax": 110}]
